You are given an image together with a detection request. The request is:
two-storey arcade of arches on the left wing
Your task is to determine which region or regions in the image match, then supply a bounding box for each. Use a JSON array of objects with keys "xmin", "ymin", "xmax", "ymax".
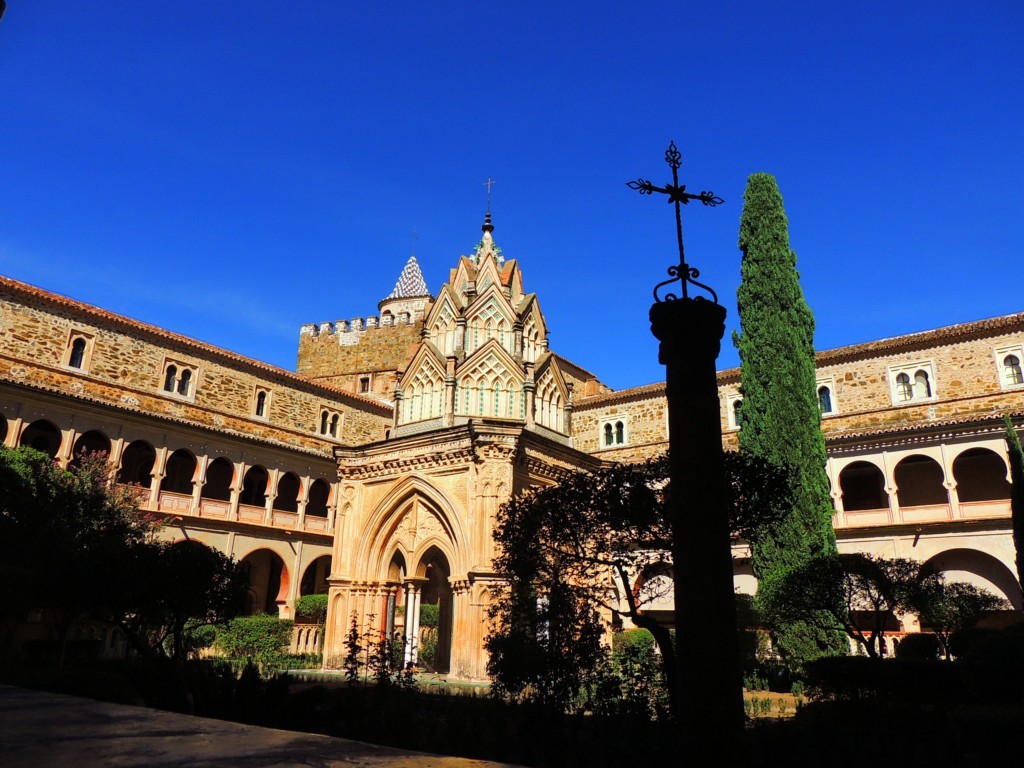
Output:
[{"xmin": 0, "ymin": 414, "xmax": 337, "ymax": 617}]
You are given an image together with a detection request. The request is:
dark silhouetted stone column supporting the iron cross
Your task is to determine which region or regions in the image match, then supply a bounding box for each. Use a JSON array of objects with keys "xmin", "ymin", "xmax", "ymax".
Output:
[{"xmin": 650, "ymin": 299, "xmax": 743, "ymax": 762}]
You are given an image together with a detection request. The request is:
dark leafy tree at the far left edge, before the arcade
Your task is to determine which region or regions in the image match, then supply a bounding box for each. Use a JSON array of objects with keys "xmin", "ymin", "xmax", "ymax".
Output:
[{"xmin": 0, "ymin": 447, "xmax": 157, "ymax": 665}]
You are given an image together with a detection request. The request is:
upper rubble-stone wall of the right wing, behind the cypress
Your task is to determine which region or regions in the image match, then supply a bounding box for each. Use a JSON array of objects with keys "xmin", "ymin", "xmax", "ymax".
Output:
[{"xmin": 572, "ymin": 314, "xmax": 1024, "ymax": 462}]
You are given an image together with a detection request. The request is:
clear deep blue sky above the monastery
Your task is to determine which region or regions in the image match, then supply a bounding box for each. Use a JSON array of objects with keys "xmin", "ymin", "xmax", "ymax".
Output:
[{"xmin": 0, "ymin": 0, "xmax": 1024, "ymax": 388}]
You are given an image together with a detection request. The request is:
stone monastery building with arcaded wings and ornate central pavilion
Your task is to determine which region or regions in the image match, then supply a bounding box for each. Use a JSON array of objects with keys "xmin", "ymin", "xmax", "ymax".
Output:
[{"xmin": 0, "ymin": 214, "xmax": 1024, "ymax": 678}]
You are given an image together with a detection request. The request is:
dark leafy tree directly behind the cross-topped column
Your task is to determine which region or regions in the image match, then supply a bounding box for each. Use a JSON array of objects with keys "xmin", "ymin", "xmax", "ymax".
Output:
[{"xmin": 485, "ymin": 454, "xmax": 788, "ymax": 709}]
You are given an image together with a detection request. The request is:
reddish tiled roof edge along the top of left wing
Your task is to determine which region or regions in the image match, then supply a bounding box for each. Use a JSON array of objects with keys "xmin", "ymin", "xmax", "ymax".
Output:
[{"xmin": 0, "ymin": 274, "xmax": 391, "ymax": 415}]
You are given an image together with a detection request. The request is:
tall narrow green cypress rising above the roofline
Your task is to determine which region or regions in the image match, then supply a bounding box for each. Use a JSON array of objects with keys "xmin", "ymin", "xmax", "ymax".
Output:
[{"xmin": 733, "ymin": 173, "xmax": 845, "ymax": 665}]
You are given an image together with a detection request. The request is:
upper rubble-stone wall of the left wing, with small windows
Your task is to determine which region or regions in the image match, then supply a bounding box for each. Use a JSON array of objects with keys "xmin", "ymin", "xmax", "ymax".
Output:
[{"xmin": 0, "ymin": 279, "xmax": 391, "ymax": 453}]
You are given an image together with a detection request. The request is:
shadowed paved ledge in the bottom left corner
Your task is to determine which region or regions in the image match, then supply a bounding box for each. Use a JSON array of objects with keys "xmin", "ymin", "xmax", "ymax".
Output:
[{"xmin": 0, "ymin": 686, "xmax": 520, "ymax": 768}]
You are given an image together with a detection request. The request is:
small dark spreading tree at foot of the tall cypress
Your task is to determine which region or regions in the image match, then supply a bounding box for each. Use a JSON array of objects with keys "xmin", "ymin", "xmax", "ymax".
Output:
[{"xmin": 764, "ymin": 552, "xmax": 920, "ymax": 658}]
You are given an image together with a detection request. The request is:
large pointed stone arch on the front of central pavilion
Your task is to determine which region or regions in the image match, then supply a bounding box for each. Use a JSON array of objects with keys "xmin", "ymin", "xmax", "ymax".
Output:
[{"xmin": 354, "ymin": 475, "xmax": 468, "ymax": 580}]
